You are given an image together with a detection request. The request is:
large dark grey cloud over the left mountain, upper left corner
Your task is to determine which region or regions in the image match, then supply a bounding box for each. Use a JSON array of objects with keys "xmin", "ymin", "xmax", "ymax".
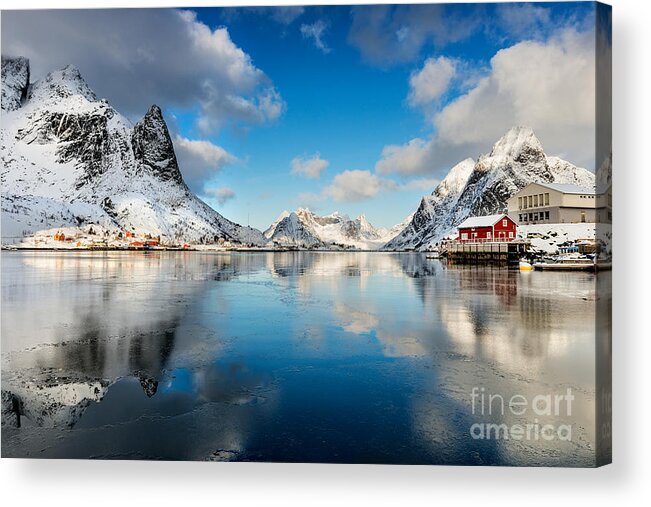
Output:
[{"xmin": 2, "ymin": 9, "xmax": 285, "ymax": 131}]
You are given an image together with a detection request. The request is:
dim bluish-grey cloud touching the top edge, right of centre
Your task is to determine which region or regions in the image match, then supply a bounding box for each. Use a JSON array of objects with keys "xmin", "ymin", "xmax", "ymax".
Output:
[{"xmin": 348, "ymin": 4, "xmax": 482, "ymax": 66}]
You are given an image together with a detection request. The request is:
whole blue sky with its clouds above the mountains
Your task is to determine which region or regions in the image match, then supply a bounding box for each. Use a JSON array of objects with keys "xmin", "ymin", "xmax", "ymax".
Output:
[{"xmin": 2, "ymin": 2, "xmax": 595, "ymax": 229}]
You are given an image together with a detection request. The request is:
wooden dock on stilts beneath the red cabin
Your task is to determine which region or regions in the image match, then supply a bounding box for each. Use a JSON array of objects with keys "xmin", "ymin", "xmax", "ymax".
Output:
[{"xmin": 442, "ymin": 240, "xmax": 531, "ymax": 266}]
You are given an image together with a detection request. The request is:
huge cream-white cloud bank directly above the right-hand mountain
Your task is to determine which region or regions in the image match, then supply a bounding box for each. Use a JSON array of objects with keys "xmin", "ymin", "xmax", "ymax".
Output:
[{"xmin": 376, "ymin": 29, "xmax": 595, "ymax": 179}]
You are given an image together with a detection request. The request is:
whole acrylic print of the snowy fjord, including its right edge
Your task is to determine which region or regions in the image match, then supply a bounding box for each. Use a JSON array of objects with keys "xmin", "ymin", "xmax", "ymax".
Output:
[{"xmin": 1, "ymin": 2, "xmax": 613, "ymax": 467}]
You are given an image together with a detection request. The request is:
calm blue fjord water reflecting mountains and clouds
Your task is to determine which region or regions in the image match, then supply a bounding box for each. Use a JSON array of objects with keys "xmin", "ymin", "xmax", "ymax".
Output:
[{"xmin": 2, "ymin": 252, "xmax": 610, "ymax": 466}]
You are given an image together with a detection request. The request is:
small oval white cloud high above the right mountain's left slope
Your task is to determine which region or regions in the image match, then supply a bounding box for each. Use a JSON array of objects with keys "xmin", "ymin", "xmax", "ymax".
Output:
[{"xmin": 409, "ymin": 56, "xmax": 457, "ymax": 106}]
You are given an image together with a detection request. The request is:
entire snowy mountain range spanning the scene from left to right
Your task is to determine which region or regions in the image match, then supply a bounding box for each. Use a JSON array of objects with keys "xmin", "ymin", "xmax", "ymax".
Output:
[{"xmin": 0, "ymin": 57, "xmax": 596, "ymax": 251}]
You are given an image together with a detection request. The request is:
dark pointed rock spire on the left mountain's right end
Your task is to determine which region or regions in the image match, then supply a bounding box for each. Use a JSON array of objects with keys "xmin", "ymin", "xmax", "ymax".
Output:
[{"xmin": 131, "ymin": 105, "xmax": 183, "ymax": 183}]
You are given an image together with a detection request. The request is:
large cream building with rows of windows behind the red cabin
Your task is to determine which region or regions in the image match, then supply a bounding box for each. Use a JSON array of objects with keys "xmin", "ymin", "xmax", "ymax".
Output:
[{"xmin": 507, "ymin": 183, "xmax": 612, "ymax": 225}]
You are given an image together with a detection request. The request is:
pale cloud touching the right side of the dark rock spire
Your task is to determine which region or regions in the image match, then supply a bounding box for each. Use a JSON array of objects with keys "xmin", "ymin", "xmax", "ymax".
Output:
[{"xmin": 174, "ymin": 135, "xmax": 238, "ymax": 191}]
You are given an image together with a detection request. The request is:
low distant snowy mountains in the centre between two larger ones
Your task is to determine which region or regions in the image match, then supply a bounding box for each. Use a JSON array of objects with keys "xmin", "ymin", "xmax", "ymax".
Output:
[{"xmin": 264, "ymin": 208, "xmax": 406, "ymax": 250}]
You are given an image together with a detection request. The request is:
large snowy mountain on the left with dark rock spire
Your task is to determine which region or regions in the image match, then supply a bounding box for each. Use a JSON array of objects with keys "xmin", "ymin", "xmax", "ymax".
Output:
[{"xmin": 0, "ymin": 57, "xmax": 263, "ymax": 245}]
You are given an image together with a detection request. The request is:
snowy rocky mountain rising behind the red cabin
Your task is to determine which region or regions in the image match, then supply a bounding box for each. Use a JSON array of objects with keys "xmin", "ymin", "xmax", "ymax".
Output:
[{"xmin": 383, "ymin": 127, "xmax": 595, "ymax": 250}]
